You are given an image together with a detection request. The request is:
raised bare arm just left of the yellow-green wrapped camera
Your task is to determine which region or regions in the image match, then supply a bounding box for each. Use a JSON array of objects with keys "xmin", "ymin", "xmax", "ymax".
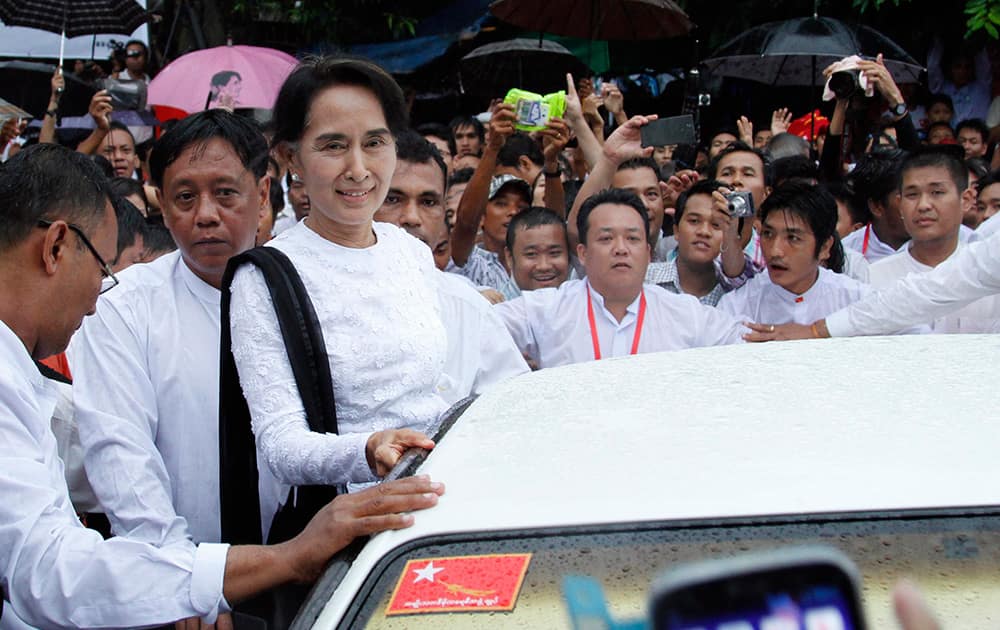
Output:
[{"xmin": 451, "ymin": 103, "xmax": 517, "ymax": 267}]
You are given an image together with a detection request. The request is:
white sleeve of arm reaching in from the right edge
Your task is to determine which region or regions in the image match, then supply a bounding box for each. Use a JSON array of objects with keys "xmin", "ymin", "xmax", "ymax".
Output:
[{"xmin": 826, "ymin": 236, "xmax": 1000, "ymax": 337}]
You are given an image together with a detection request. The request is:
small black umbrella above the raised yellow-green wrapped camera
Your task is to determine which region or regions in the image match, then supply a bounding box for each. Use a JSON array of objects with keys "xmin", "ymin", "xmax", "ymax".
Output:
[{"xmin": 461, "ymin": 39, "xmax": 590, "ymax": 98}]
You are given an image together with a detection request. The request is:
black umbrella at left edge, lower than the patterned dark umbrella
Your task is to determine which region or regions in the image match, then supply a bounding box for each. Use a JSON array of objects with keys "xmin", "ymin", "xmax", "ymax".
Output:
[{"xmin": 0, "ymin": 61, "xmax": 96, "ymax": 118}]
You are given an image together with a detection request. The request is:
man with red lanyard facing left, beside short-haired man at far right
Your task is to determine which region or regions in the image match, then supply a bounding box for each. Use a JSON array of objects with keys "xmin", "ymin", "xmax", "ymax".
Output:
[{"xmin": 842, "ymin": 150, "xmax": 910, "ymax": 263}]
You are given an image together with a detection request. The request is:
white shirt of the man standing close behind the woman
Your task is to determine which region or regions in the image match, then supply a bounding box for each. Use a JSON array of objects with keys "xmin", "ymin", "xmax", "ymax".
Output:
[{"xmin": 69, "ymin": 251, "xmax": 221, "ymax": 543}]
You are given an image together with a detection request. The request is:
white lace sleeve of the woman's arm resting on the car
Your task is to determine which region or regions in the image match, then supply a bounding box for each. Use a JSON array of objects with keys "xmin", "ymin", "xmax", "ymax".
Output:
[{"xmin": 229, "ymin": 265, "xmax": 376, "ymax": 486}]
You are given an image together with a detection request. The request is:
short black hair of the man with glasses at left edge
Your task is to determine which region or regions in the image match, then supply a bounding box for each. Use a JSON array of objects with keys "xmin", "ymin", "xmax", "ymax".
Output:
[{"xmin": 0, "ymin": 143, "xmax": 110, "ymax": 251}]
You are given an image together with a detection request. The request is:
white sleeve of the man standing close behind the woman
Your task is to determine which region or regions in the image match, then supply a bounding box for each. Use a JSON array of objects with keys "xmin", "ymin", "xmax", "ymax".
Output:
[{"xmin": 72, "ymin": 299, "xmax": 188, "ymax": 545}]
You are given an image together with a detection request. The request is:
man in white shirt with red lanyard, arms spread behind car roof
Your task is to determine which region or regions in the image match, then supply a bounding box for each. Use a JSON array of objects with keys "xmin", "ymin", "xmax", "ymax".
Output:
[{"xmin": 494, "ymin": 186, "xmax": 742, "ymax": 368}]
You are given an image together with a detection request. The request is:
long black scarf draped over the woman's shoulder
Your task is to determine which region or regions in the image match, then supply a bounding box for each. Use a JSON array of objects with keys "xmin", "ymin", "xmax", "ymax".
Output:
[{"xmin": 219, "ymin": 247, "xmax": 337, "ymax": 544}]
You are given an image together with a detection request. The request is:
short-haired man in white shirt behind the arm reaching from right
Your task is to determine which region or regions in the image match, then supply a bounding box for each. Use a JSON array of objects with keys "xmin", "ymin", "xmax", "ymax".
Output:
[{"xmin": 868, "ymin": 152, "xmax": 1000, "ymax": 333}]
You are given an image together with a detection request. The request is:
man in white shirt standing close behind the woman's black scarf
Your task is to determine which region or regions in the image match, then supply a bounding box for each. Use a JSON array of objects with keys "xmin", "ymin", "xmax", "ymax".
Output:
[{"xmin": 70, "ymin": 108, "xmax": 430, "ymax": 544}]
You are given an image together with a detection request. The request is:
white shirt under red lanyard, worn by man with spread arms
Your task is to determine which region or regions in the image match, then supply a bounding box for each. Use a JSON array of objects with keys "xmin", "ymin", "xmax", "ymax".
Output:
[{"xmin": 493, "ymin": 280, "xmax": 743, "ymax": 368}]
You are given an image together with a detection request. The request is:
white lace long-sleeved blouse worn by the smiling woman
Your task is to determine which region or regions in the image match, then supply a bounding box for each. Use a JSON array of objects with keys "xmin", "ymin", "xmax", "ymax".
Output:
[{"xmin": 230, "ymin": 222, "xmax": 448, "ymax": 485}]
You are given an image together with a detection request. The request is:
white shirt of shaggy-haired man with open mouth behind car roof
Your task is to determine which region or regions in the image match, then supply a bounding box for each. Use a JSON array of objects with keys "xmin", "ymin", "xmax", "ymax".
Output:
[{"xmin": 718, "ymin": 267, "xmax": 871, "ymax": 324}]
